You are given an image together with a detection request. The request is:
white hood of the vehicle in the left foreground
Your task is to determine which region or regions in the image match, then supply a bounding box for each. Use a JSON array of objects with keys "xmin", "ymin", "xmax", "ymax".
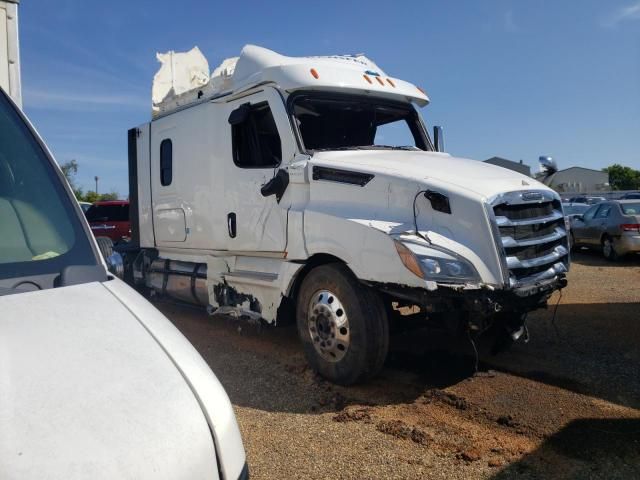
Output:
[{"xmin": 0, "ymin": 282, "xmax": 218, "ymax": 479}]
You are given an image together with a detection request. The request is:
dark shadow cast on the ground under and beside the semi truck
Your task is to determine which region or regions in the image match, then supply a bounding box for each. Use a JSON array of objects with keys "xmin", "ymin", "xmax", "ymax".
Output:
[{"xmin": 161, "ymin": 296, "xmax": 640, "ymax": 413}]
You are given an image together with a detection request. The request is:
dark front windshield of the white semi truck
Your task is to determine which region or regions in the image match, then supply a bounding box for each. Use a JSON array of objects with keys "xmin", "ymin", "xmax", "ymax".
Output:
[{"xmin": 291, "ymin": 93, "xmax": 431, "ymax": 151}]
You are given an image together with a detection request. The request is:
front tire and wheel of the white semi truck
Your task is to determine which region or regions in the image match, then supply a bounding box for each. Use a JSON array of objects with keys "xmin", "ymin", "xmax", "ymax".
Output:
[{"xmin": 296, "ymin": 263, "xmax": 389, "ymax": 385}]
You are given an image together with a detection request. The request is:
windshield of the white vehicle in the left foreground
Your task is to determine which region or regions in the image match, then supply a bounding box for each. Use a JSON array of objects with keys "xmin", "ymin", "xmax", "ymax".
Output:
[{"xmin": 0, "ymin": 90, "xmax": 97, "ymax": 280}]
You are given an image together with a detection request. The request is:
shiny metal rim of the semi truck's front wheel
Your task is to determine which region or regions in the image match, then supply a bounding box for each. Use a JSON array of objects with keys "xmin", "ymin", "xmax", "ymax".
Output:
[{"xmin": 307, "ymin": 290, "xmax": 351, "ymax": 362}]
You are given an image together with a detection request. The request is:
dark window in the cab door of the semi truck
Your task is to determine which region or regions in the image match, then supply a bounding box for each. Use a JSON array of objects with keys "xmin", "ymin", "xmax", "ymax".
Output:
[{"xmin": 231, "ymin": 102, "xmax": 282, "ymax": 168}]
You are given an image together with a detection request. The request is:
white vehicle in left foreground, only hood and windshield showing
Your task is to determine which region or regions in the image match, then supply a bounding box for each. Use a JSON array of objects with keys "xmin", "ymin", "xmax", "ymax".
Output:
[{"xmin": 0, "ymin": 89, "xmax": 247, "ymax": 480}]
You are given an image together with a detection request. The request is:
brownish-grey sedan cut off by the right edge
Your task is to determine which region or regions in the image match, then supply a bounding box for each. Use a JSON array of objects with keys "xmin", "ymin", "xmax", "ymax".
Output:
[{"xmin": 571, "ymin": 200, "xmax": 640, "ymax": 260}]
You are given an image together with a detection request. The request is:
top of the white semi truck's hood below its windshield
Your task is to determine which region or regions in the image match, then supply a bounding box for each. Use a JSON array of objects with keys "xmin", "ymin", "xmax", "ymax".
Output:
[{"xmin": 312, "ymin": 150, "xmax": 548, "ymax": 197}]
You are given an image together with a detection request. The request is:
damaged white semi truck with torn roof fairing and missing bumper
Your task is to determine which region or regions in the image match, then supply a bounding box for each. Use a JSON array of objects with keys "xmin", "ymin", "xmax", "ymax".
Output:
[{"xmin": 127, "ymin": 45, "xmax": 569, "ymax": 384}]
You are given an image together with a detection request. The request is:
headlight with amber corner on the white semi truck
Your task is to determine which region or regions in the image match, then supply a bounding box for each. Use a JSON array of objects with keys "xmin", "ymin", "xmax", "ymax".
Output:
[{"xmin": 394, "ymin": 240, "xmax": 480, "ymax": 283}]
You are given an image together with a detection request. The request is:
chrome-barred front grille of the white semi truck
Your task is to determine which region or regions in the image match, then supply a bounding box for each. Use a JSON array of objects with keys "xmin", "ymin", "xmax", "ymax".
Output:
[{"xmin": 492, "ymin": 191, "xmax": 569, "ymax": 287}]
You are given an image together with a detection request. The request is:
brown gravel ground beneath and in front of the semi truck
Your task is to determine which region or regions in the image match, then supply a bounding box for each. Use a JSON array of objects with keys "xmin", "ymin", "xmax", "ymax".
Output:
[{"xmin": 157, "ymin": 252, "xmax": 640, "ymax": 479}]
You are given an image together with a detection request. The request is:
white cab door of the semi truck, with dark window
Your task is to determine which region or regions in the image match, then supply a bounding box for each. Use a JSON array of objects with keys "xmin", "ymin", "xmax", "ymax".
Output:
[{"xmin": 223, "ymin": 88, "xmax": 295, "ymax": 254}]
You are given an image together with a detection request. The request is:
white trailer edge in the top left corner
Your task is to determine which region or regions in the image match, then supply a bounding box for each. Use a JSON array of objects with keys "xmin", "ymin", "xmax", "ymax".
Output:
[{"xmin": 0, "ymin": 0, "xmax": 22, "ymax": 108}]
